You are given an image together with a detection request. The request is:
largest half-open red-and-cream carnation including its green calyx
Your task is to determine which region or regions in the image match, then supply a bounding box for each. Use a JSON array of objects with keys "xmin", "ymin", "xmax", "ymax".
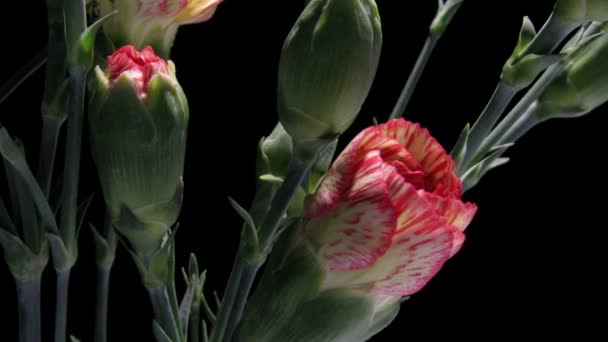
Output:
[{"xmin": 241, "ymin": 119, "xmax": 477, "ymax": 342}]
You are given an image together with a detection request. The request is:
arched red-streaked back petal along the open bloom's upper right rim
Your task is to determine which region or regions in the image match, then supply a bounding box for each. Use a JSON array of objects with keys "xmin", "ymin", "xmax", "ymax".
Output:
[{"xmin": 377, "ymin": 118, "xmax": 461, "ymax": 198}]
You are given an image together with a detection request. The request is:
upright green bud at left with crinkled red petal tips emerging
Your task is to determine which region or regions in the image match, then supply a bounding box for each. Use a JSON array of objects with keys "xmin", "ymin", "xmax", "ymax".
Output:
[{"xmin": 89, "ymin": 46, "xmax": 188, "ymax": 253}]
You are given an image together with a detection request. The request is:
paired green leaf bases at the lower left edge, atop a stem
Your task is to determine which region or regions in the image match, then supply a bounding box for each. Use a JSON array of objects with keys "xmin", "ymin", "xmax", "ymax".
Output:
[{"xmin": 0, "ymin": 228, "xmax": 49, "ymax": 279}]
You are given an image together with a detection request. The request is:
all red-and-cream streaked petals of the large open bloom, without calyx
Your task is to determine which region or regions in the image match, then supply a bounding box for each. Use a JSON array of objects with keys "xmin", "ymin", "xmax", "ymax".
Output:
[{"xmin": 304, "ymin": 119, "xmax": 477, "ymax": 296}]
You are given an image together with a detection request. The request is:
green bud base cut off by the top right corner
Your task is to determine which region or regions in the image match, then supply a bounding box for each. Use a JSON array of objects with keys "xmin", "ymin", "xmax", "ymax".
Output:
[{"xmin": 553, "ymin": 0, "xmax": 608, "ymax": 24}]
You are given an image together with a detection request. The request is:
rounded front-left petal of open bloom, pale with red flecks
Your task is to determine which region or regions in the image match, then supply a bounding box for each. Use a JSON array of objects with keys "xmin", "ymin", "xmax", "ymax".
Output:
[{"xmin": 304, "ymin": 151, "xmax": 397, "ymax": 270}]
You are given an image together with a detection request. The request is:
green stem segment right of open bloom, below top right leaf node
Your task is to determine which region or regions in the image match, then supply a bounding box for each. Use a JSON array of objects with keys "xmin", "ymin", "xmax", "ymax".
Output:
[{"xmin": 459, "ymin": 81, "xmax": 518, "ymax": 174}]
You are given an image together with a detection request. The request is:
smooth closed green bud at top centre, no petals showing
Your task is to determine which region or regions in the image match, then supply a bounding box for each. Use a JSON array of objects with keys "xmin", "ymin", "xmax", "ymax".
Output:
[{"xmin": 278, "ymin": 0, "xmax": 382, "ymax": 141}]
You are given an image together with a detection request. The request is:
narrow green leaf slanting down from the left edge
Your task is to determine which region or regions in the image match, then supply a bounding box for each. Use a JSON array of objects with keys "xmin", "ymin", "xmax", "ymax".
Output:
[{"xmin": 0, "ymin": 127, "xmax": 58, "ymax": 232}]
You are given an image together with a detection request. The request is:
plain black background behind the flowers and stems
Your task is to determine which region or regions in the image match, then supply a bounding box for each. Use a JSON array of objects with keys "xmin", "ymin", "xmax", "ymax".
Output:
[{"xmin": 0, "ymin": 0, "xmax": 608, "ymax": 341}]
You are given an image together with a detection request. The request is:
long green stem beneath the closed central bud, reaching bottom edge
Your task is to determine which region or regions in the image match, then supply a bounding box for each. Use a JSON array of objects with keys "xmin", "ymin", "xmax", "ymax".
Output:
[{"xmin": 210, "ymin": 141, "xmax": 328, "ymax": 342}]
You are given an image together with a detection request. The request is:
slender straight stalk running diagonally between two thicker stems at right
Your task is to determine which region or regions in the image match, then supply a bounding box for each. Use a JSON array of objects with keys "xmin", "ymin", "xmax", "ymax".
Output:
[{"xmin": 465, "ymin": 61, "xmax": 565, "ymax": 168}]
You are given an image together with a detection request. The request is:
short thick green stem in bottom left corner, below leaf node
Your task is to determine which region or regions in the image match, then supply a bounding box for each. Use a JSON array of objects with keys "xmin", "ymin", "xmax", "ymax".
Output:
[{"xmin": 15, "ymin": 276, "xmax": 41, "ymax": 342}]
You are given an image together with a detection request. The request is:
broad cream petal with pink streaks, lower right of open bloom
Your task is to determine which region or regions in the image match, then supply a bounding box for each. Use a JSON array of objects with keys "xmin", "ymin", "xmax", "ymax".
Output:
[{"xmin": 325, "ymin": 179, "xmax": 454, "ymax": 296}]
